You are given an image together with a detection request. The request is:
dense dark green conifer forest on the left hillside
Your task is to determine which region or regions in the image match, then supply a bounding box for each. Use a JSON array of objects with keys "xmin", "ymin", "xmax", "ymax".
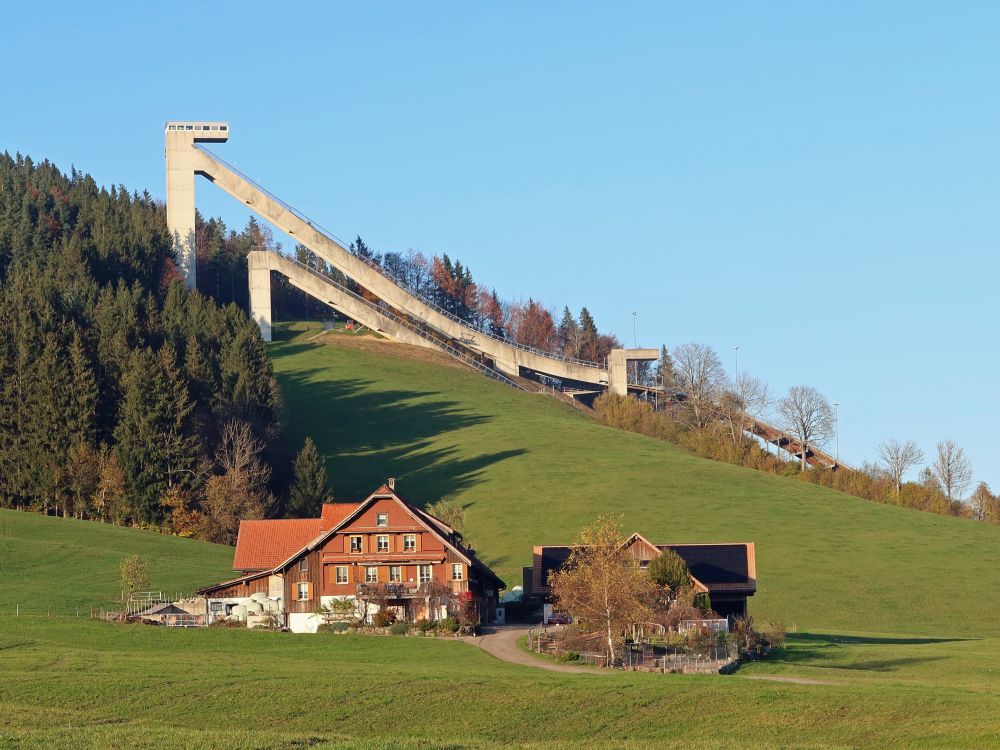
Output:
[{"xmin": 0, "ymin": 154, "xmax": 288, "ymax": 542}]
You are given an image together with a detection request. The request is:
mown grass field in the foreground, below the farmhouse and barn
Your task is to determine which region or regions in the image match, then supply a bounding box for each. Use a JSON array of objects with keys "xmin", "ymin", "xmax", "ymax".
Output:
[{"xmin": 0, "ymin": 617, "xmax": 1000, "ymax": 749}]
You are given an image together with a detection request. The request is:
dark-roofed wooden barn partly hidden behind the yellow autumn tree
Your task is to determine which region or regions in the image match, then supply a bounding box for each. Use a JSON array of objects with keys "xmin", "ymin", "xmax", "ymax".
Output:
[{"xmin": 524, "ymin": 534, "xmax": 757, "ymax": 617}]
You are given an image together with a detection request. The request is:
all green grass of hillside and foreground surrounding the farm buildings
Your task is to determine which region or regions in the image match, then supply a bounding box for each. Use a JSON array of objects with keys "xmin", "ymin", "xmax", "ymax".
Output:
[{"xmin": 0, "ymin": 327, "xmax": 1000, "ymax": 750}]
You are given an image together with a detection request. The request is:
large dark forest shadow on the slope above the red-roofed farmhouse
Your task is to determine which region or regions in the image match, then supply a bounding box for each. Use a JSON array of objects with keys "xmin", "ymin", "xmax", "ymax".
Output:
[{"xmin": 278, "ymin": 370, "xmax": 526, "ymax": 505}]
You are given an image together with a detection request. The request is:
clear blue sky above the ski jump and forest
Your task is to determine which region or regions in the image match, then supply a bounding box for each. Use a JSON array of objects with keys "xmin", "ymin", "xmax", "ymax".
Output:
[{"xmin": 0, "ymin": 0, "xmax": 1000, "ymax": 491}]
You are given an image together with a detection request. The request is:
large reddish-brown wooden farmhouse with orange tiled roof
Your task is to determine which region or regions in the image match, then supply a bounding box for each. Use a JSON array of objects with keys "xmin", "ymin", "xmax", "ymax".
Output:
[{"xmin": 198, "ymin": 480, "xmax": 504, "ymax": 633}]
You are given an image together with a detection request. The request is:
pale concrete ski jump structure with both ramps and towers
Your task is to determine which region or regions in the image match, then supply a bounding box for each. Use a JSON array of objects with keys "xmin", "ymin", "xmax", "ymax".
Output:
[{"xmin": 165, "ymin": 121, "xmax": 659, "ymax": 394}]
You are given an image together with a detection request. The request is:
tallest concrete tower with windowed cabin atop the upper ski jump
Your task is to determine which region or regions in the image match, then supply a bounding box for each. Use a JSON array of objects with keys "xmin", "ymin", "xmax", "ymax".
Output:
[{"xmin": 164, "ymin": 122, "xmax": 229, "ymax": 289}]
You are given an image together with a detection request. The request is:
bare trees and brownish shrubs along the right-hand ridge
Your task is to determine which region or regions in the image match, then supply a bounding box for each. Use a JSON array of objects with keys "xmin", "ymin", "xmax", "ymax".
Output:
[{"xmin": 594, "ymin": 343, "xmax": 1000, "ymax": 524}]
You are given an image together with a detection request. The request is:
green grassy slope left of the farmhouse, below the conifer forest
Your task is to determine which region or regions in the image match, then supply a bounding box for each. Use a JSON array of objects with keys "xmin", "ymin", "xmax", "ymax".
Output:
[{"xmin": 0, "ymin": 510, "xmax": 233, "ymax": 615}]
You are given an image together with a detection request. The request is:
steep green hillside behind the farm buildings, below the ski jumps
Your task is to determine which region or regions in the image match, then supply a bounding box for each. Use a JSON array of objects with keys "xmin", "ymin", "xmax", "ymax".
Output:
[{"xmin": 270, "ymin": 325, "xmax": 1000, "ymax": 636}]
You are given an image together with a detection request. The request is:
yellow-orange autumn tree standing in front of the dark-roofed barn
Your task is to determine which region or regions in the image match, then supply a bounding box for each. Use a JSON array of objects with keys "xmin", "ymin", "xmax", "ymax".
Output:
[{"xmin": 549, "ymin": 516, "xmax": 657, "ymax": 661}]
